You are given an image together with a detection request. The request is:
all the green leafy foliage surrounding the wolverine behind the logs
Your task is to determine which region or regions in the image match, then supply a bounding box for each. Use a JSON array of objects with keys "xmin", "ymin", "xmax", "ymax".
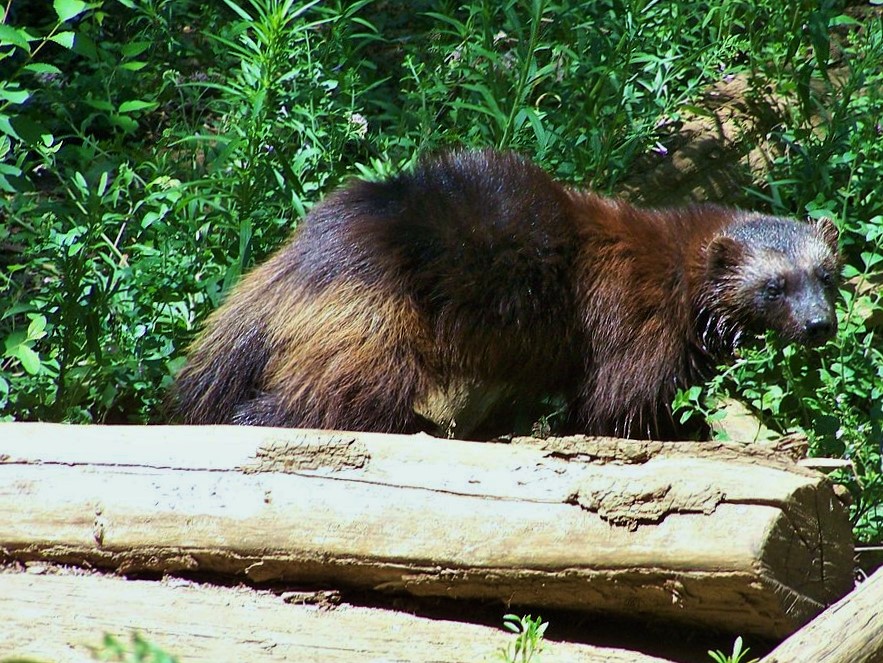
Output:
[{"xmin": 0, "ymin": 0, "xmax": 883, "ymax": 540}]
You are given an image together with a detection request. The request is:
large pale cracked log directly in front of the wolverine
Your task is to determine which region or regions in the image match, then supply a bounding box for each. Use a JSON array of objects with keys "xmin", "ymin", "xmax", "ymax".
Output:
[{"xmin": 0, "ymin": 424, "xmax": 853, "ymax": 637}]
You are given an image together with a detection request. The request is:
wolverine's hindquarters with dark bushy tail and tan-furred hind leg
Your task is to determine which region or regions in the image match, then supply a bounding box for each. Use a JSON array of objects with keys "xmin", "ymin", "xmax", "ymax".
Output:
[{"xmin": 166, "ymin": 266, "xmax": 429, "ymax": 433}]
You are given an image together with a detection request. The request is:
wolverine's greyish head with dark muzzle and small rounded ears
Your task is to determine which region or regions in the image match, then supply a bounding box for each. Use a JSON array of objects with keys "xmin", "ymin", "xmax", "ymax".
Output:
[{"xmin": 706, "ymin": 215, "xmax": 840, "ymax": 345}]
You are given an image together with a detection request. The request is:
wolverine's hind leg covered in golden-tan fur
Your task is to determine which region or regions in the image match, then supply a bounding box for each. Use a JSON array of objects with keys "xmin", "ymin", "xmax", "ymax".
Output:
[{"xmin": 260, "ymin": 283, "xmax": 430, "ymax": 433}]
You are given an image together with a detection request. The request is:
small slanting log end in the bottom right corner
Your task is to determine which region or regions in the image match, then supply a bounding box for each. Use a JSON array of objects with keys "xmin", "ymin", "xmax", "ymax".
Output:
[{"xmin": 762, "ymin": 569, "xmax": 883, "ymax": 663}]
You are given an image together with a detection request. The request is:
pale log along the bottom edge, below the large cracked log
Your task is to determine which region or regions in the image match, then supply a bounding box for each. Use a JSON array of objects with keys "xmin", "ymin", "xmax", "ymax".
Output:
[{"xmin": 0, "ymin": 573, "xmax": 666, "ymax": 663}]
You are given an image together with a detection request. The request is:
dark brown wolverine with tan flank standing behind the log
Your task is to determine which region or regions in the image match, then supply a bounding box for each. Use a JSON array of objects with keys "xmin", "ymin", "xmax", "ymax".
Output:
[{"xmin": 169, "ymin": 150, "xmax": 840, "ymax": 439}]
